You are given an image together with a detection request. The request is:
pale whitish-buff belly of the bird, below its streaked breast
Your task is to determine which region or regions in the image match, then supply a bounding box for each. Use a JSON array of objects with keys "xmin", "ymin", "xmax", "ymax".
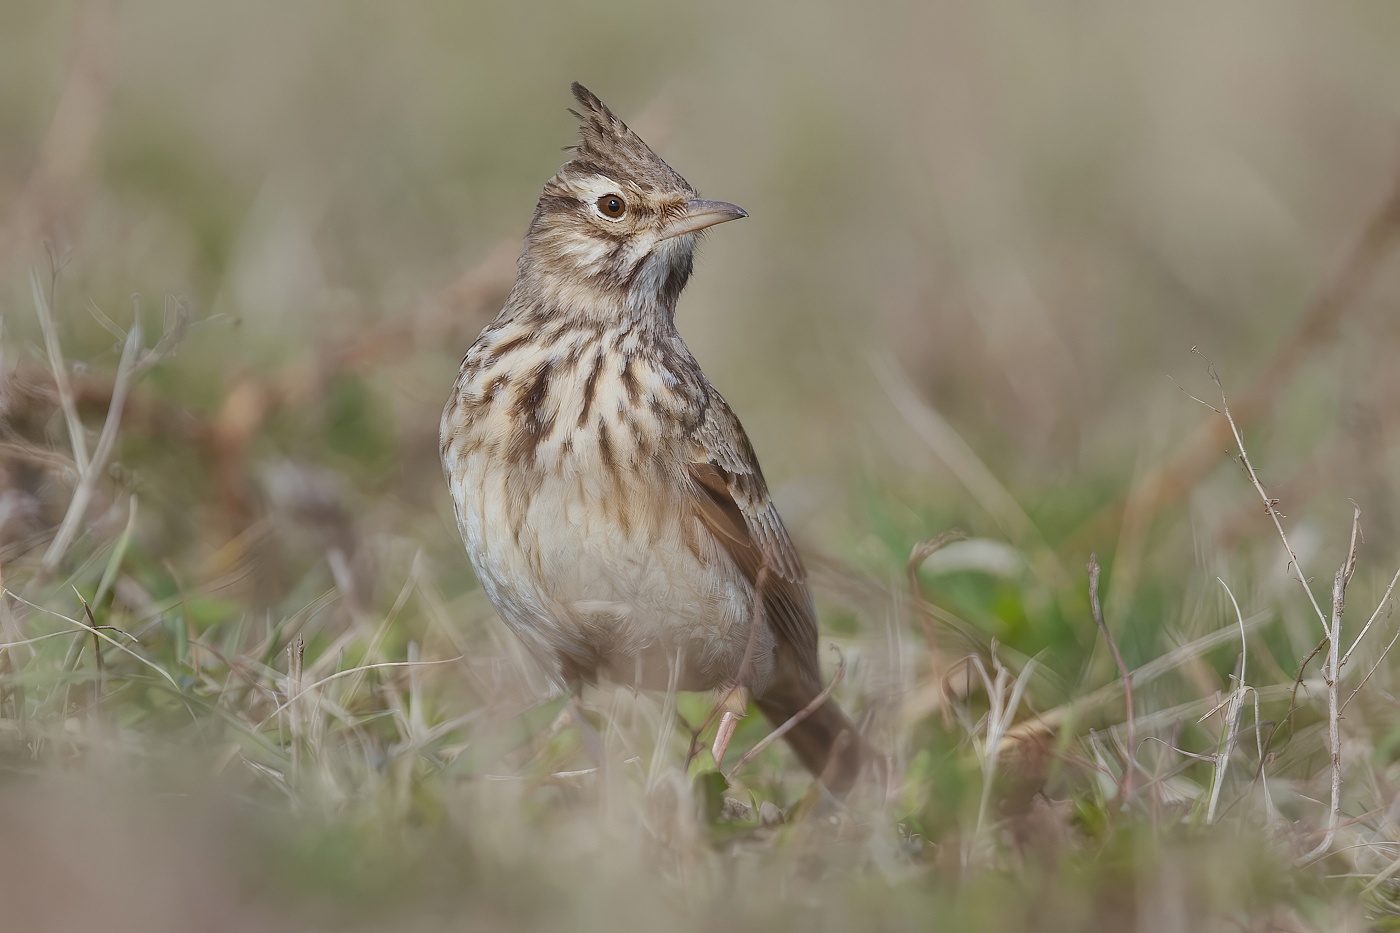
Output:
[{"xmin": 451, "ymin": 454, "xmax": 773, "ymax": 689}]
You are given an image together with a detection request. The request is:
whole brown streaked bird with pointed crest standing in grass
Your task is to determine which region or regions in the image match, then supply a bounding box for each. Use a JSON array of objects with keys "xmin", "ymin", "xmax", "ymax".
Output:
[{"xmin": 440, "ymin": 83, "xmax": 871, "ymax": 794}]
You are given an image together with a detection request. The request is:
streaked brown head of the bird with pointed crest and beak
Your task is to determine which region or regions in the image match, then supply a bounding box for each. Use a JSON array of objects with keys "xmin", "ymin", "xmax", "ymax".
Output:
[{"xmin": 519, "ymin": 83, "xmax": 748, "ymax": 323}]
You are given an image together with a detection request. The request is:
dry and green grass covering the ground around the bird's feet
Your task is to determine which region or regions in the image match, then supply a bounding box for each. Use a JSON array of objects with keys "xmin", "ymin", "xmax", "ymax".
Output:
[{"xmin": 8, "ymin": 240, "xmax": 1400, "ymax": 929}]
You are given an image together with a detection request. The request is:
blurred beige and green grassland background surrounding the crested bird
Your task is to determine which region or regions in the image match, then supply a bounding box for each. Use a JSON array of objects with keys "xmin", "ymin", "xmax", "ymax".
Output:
[{"xmin": 0, "ymin": 0, "xmax": 1400, "ymax": 929}]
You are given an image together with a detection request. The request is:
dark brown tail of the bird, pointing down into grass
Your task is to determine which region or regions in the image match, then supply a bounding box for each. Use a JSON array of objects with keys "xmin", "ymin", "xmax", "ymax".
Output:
[{"xmin": 757, "ymin": 672, "xmax": 875, "ymax": 796}]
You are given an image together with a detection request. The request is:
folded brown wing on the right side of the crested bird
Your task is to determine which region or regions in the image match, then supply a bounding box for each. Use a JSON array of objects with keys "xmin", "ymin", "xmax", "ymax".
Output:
[{"xmin": 689, "ymin": 395, "xmax": 820, "ymax": 684}]
